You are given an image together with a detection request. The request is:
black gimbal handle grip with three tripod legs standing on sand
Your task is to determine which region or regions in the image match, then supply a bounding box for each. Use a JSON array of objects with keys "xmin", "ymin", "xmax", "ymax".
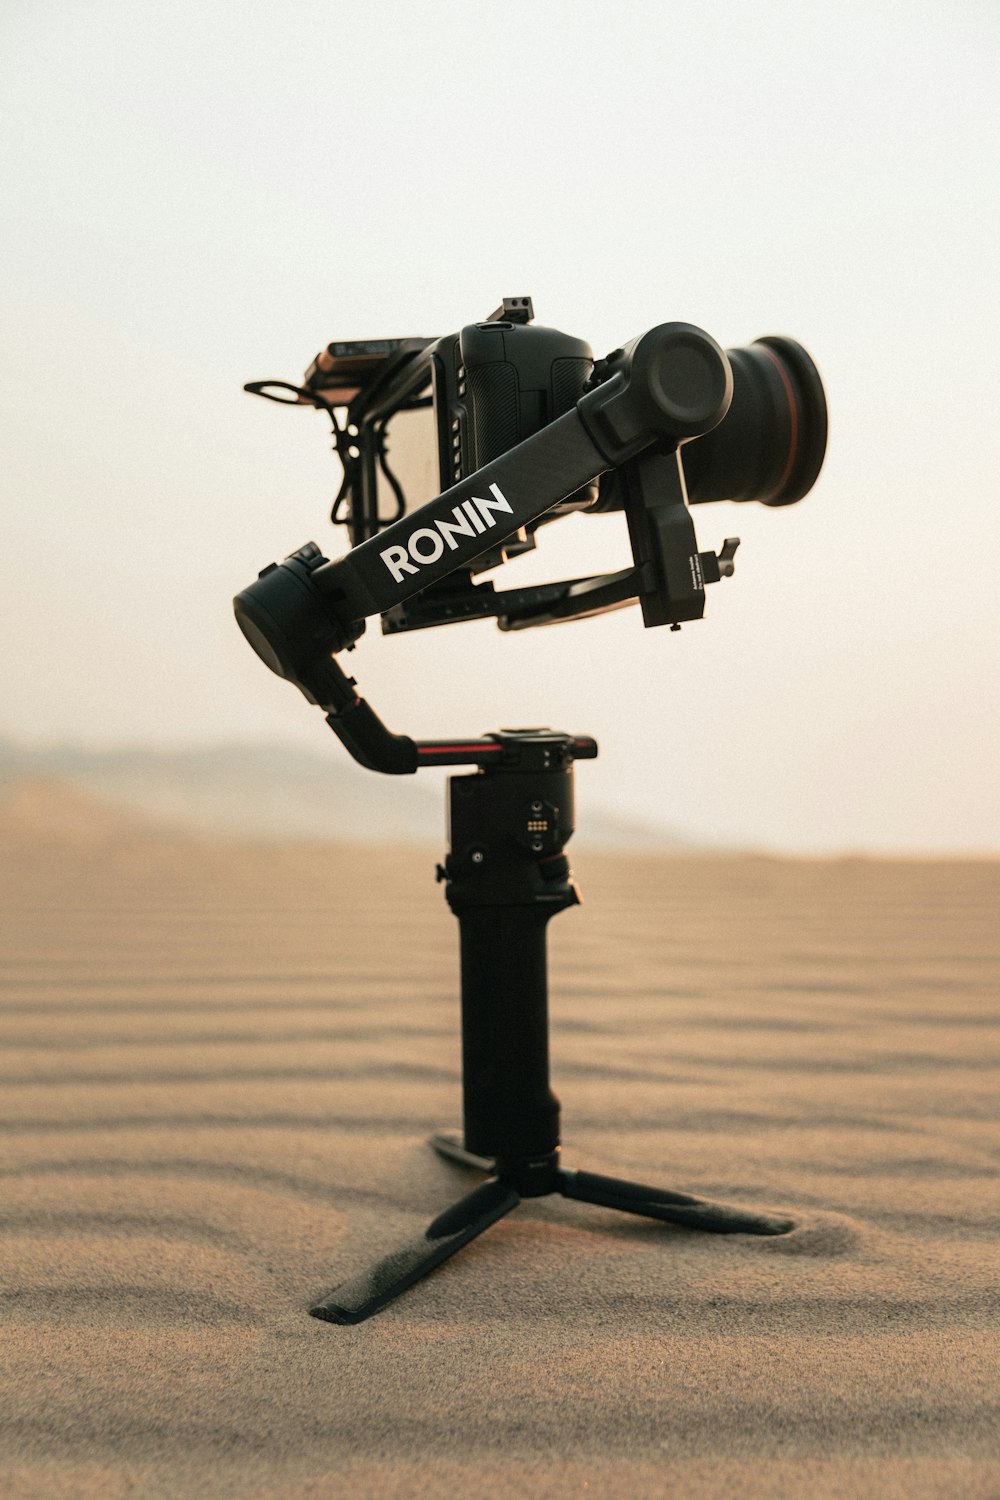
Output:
[{"xmin": 309, "ymin": 729, "xmax": 795, "ymax": 1323}]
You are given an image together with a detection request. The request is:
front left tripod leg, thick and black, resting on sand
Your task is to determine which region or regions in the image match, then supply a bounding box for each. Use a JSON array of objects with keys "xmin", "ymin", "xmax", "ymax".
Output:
[{"xmin": 309, "ymin": 1178, "xmax": 520, "ymax": 1323}]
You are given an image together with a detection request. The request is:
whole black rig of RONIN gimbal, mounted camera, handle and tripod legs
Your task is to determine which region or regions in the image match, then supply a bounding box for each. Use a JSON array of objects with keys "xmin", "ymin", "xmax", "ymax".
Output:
[{"xmin": 234, "ymin": 299, "xmax": 826, "ymax": 1323}]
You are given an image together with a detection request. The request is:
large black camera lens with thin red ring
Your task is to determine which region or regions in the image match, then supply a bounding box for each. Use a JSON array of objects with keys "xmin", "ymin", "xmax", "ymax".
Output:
[{"xmin": 684, "ymin": 338, "xmax": 826, "ymax": 506}]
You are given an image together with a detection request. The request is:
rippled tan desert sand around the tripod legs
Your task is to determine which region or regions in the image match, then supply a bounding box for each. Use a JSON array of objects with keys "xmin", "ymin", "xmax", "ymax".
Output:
[{"xmin": 0, "ymin": 818, "xmax": 1000, "ymax": 1500}]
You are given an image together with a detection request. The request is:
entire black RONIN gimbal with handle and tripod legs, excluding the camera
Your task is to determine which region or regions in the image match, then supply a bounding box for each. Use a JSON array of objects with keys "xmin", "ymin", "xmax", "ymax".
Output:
[{"xmin": 234, "ymin": 310, "xmax": 826, "ymax": 1323}]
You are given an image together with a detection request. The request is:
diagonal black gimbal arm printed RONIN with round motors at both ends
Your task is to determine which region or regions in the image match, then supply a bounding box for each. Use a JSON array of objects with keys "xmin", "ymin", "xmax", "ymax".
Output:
[{"xmin": 234, "ymin": 323, "xmax": 733, "ymax": 773}]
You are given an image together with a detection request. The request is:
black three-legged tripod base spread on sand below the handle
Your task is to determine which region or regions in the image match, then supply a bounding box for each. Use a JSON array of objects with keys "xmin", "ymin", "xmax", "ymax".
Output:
[{"xmin": 309, "ymin": 1136, "xmax": 795, "ymax": 1323}]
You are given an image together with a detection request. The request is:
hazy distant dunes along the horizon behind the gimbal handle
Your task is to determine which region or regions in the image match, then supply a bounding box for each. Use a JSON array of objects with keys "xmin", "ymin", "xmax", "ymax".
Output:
[{"xmin": 0, "ymin": 740, "xmax": 697, "ymax": 852}]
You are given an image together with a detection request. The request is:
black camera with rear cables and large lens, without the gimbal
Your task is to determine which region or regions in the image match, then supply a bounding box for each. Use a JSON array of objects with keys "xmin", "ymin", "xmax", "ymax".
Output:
[{"xmin": 246, "ymin": 297, "xmax": 826, "ymax": 633}]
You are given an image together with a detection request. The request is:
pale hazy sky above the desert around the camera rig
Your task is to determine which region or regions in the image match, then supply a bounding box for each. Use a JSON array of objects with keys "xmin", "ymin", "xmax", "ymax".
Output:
[{"xmin": 0, "ymin": 0, "xmax": 1000, "ymax": 851}]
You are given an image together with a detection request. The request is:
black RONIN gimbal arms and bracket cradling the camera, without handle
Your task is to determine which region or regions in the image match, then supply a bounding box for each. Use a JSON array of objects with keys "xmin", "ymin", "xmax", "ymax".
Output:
[{"xmin": 234, "ymin": 323, "xmax": 739, "ymax": 774}]
